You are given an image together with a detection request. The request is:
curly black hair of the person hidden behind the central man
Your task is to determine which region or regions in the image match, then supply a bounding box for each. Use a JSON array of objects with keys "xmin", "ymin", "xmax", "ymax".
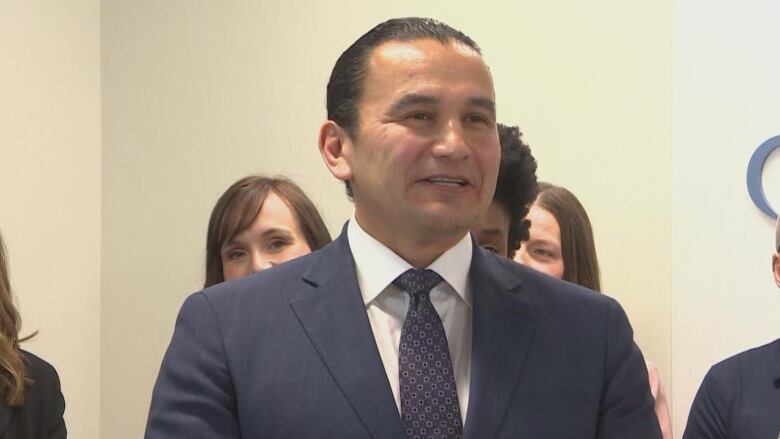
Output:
[{"xmin": 493, "ymin": 124, "xmax": 539, "ymax": 258}]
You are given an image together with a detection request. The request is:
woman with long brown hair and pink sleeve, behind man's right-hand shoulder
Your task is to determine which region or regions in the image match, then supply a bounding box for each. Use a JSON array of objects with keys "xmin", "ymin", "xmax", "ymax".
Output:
[{"xmin": 515, "ymin": 182, "xmax": 672, "ymax": 439}]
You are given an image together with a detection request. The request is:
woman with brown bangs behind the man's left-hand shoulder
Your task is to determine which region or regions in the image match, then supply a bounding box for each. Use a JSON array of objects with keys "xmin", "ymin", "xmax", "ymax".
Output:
[{"xmin": 204, "ymin": 175, "xmax": 331, "ymax": 287}]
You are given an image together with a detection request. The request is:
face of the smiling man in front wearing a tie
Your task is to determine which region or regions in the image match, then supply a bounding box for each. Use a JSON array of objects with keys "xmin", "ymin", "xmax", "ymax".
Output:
[{"xmin": 344, "ymin": 39, "xmax": 500, "ymax": 248}]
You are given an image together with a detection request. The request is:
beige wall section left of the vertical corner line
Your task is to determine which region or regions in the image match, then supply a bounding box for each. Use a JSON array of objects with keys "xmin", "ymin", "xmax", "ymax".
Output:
[{"xmin": 0, "ymin": 0, "xmax": 101, "ymax": 439}]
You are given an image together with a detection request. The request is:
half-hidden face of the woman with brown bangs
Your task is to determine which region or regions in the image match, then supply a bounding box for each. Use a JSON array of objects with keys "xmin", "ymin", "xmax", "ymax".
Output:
[{"xmin": 220, "ymin": 192, "xmax": 311, "ymax": 280}]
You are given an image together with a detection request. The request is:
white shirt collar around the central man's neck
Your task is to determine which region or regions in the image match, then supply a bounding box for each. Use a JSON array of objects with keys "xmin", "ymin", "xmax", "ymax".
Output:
[{"xmin": 347, "ymin": 214, "xmax": 472, "ymax": 307}]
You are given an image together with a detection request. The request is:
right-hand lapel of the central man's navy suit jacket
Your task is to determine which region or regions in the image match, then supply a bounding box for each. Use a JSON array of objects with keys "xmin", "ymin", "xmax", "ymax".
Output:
[{"xmin": 464, "ymin": 248, "xmax": 536, "ymax": 438}]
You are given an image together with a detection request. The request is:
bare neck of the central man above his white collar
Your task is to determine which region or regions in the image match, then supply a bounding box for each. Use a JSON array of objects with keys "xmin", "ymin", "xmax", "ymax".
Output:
[{"xmin": 355, "ymin": 215, "xmax": 468, "ymax": 269}]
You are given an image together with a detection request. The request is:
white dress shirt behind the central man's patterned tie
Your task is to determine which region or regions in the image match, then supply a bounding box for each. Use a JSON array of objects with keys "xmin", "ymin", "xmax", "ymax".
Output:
[{"xmin": 347, "ymin": 215, "xmax": 473, "ymax": 424}]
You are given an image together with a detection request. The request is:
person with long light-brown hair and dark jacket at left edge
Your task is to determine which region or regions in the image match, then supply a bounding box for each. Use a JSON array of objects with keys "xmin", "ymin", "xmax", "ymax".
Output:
[{"xmin": 0, "ymin": 232, "xmax": 67, "ymax": 439}]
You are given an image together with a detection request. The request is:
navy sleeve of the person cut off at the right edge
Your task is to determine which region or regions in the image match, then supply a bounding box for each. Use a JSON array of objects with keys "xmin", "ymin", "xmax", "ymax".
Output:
[{"xmin": 683, "ymin": 369, "xmax": 727, "ymax": 439}]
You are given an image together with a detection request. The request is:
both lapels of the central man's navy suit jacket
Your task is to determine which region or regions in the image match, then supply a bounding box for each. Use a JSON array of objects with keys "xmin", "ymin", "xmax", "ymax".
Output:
[{"xmin": 290, "ymin": 229, "xmax": 537, "ymax": 439}]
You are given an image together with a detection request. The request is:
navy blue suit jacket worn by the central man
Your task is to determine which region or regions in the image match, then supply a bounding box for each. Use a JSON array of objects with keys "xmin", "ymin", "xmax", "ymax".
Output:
[{"xmin": 146, "ymin": 229, "xmax": 661, "ymax": 439}]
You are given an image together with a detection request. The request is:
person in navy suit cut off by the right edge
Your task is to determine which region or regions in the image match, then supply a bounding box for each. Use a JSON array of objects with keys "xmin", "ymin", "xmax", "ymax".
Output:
[{"xmin": 683, "ymin": 218, "xmax": 780, "ymax": 439}]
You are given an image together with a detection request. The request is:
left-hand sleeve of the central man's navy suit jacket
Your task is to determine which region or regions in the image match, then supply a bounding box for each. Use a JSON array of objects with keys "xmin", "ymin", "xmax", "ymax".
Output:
[{"xmin": 145, "ymin": 293, "xmax": 240, "ymax": 439}]
